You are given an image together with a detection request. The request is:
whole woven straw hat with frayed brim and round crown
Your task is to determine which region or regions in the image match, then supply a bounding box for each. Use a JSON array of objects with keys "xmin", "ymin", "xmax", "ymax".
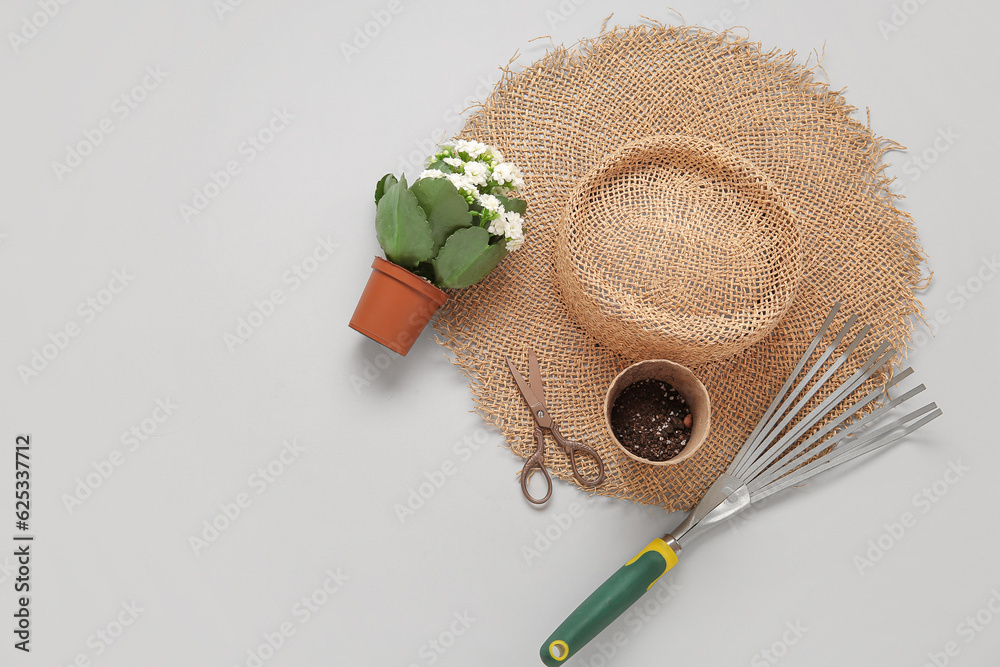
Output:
[{"xmin": 435, "ymin": 26, "xmax": 922, "ymax": 510}]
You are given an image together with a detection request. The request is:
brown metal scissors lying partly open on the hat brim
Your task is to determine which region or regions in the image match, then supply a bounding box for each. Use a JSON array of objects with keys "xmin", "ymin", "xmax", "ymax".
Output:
[{"xmin": 504, "ymin": 349, "xmax": 604, "ymax": 505}]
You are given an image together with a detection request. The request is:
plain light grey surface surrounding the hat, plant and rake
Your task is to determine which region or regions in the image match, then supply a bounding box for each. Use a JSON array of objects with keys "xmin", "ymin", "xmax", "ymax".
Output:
[{"xmin": 0, "ymin": 0, "xmax": 1000, "ymax": 667}]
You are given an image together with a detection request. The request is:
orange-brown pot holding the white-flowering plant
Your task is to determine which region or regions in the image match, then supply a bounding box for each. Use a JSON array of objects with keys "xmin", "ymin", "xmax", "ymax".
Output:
[{"xmin": 350, "ymin": 257, "xmax": 448, "ymax": 357}]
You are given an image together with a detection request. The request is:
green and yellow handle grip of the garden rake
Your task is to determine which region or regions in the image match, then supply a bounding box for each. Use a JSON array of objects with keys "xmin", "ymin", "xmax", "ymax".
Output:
[{"xmin": 539, "ymin": 538, "xmax": 677, "ymax": 667}]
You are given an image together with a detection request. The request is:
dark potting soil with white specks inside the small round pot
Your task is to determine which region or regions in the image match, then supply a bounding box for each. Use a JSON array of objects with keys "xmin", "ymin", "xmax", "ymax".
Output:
[{"xmin": 611, "ymin": 378, "xmax": 691, "ymax": 461}]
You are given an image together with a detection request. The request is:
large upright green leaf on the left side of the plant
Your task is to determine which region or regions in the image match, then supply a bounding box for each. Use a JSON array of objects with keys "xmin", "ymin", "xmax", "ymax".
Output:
[{"xmin": 375, "ymin": 176, "xmax": 434, "ymax": 269}]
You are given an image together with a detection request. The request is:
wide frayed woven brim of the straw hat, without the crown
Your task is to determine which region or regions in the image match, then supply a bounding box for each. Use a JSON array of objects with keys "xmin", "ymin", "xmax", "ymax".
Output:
[{"xmin": 435, "ymin": 26, "xmax": 923, "ymax": 510}]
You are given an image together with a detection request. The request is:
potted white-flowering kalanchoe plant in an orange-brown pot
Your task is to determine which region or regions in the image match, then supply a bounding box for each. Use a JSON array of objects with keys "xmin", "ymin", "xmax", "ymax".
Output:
[{"xmin": 350, "ymin": 139, "xmax": 527, "ymax": 356}]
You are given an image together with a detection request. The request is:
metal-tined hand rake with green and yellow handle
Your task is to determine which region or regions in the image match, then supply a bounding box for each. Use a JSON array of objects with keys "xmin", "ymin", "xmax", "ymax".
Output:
[{"xmin": 540, "ymin": 303, "xmax": 941, "ymax": 667}]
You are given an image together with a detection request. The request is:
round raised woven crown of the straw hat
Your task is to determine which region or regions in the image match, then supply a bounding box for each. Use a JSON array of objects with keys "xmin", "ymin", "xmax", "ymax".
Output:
[{"xmin": 554, "ymin": 135, "xmax": 802, "ymax": 364}]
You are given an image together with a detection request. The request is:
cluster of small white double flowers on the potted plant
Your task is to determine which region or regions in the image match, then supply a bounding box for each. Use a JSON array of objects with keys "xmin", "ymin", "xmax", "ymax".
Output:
[{"xmin": 420, "ymin": 139, "xmax": 524, "ymax": 251}]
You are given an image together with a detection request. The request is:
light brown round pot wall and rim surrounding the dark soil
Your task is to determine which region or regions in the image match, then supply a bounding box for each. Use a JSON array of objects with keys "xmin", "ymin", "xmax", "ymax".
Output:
[{"xmin": 604, "ymin": 359, "xmax": 712, "ymax": 466}]
